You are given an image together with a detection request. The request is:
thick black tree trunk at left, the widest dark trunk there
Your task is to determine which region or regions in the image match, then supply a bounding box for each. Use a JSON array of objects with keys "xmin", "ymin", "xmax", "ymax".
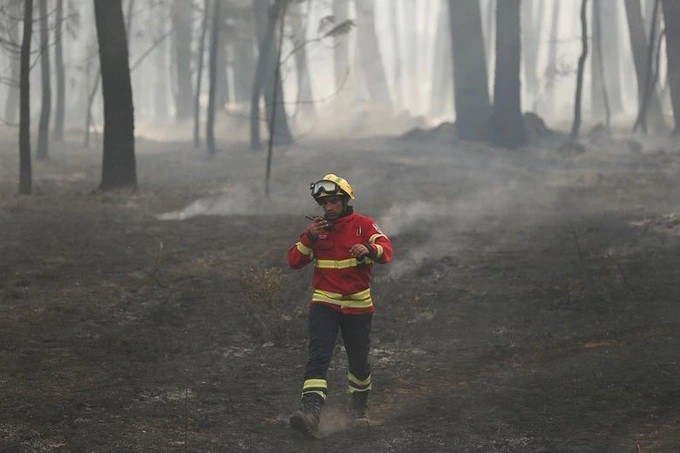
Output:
[{"xmin": 94, "ymin": 0, "xmax": 137, "ymax": 190}]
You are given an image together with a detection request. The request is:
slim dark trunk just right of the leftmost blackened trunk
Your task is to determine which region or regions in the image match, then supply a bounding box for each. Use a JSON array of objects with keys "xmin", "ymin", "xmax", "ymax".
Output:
[{"xmin": 36, "ymin": 0, "xmax": 52, "ymax": 160}]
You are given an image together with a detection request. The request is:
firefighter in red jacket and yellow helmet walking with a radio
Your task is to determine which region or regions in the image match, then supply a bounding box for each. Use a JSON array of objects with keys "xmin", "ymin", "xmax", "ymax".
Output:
[{"xmin": 288, "ymin": 174, "xmax": 392, "ymax": 438}]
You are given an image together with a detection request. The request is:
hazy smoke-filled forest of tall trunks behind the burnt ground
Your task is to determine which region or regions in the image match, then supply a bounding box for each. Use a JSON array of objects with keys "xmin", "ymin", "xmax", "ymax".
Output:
[{"xmin": 0, "ymin": 0, "xmax": 680, "ymax": 195}]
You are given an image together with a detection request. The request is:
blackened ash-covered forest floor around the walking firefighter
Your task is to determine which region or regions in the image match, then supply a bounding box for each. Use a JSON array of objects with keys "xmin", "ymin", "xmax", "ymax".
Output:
[{"xmin": 0, "ymin": 129, "xmax": 680, "ymax": 452}]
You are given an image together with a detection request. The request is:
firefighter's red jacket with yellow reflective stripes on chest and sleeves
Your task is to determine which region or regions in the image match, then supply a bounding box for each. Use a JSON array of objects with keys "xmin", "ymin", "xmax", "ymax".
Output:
[{"xmin": 288, "ymin": 213, "xmax": 392, "ymax": 314}]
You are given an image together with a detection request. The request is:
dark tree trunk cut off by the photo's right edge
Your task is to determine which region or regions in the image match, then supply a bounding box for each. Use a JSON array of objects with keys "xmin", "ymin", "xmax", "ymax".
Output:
[{"xmin": 662, "ymin": 0, "xmax": 680, "ymax": 134}]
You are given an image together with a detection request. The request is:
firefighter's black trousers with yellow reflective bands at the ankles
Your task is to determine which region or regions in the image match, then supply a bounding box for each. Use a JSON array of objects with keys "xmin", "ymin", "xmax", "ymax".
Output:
[{"xmin": 303, "ymin": 304, "xmax": 373, "ymax": 397}]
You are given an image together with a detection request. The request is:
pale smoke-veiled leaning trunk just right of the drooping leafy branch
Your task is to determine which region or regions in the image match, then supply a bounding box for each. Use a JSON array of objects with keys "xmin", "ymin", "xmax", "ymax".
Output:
[{"xmin": 356, "ymin": 0, "xmax": 392, "ymax": 110}]
